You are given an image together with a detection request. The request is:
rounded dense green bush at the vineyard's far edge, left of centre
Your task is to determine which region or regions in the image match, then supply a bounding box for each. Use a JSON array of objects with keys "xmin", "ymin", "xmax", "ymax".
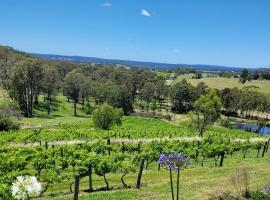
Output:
[{"xmin": 93, "ymin": 103, "xmax": 123, "ymax": 130}]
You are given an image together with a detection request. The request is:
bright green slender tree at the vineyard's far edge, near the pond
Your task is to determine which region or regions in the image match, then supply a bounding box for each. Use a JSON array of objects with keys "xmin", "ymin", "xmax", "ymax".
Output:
[{"xmin": 190, "ymin": 90, "xmax": 222, "ymax": 137}]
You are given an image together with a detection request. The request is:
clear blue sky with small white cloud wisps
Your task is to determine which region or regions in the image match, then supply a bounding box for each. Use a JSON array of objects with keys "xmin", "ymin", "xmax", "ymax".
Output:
[{"xmin": 0, "ymin": 0, "xmax": 270, "ymax": 68}]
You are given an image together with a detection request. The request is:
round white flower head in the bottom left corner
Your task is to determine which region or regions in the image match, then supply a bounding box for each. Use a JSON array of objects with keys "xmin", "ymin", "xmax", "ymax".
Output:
[{"xmin": 12, "ymin": 176, "xmax": 41, "ymax": 200}]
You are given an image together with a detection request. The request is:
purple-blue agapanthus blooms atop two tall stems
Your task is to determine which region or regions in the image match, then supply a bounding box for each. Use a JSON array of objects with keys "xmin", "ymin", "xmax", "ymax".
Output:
[{"xmin": 158, "ymin": 153, "xmax": 191, "ymax": 171}]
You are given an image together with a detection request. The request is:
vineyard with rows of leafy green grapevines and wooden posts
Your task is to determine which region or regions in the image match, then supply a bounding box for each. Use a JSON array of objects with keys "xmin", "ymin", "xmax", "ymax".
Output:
[{"xmin": 0, "ymin": 117, "xmax": 270, "ymax": 199}]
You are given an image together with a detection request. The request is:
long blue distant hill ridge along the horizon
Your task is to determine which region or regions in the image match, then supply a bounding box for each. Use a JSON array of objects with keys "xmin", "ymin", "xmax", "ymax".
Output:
[{"xmin": 32, "ymin": 53, "xmax": 249, "ymax": 72}]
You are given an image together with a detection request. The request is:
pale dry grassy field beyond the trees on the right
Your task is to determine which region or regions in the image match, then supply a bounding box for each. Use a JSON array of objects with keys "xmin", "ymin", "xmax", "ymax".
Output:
[{"xmin": 173, "ymin": 74, "xmax": 270, "ymax": 95}]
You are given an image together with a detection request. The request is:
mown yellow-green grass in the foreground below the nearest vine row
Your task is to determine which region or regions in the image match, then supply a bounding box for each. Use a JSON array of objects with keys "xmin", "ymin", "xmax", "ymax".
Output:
[{"xmin": 39, "ymin": 151, "xmax": 270, "ymax": 200}]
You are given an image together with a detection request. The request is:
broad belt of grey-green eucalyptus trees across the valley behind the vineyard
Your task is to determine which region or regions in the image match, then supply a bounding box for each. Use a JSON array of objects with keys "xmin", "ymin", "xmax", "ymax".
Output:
[{"xmin": 0, "ymin": 47, "xmax": 270, "ymax": 123}]
